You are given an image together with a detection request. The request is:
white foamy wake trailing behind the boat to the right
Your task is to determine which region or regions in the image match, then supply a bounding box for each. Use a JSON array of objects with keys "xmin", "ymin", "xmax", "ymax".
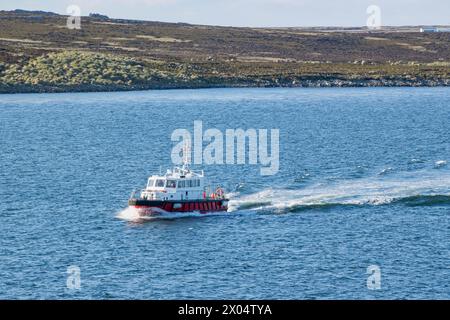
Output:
[{"xmin": 229, "ymin": 170, "xmax": 450, "ymax": 211}]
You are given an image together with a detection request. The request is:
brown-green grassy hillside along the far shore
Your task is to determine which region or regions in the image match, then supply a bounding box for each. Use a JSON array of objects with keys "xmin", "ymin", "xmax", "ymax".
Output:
[{"xmin": 0, "ymin": 11, "xmax": 450, "ymax": 93}]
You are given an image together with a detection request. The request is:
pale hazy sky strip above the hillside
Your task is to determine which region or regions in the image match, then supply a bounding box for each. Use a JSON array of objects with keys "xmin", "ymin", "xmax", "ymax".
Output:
[{"xmin": 0, "ymin": 0, "xmax": 450, "ymax": 27}]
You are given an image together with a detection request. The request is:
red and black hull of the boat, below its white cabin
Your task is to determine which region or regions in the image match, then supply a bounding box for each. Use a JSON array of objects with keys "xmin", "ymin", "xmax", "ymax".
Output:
[{"xmin": 128, "ymin": 199, "xmax": 228, "ymax": 216}]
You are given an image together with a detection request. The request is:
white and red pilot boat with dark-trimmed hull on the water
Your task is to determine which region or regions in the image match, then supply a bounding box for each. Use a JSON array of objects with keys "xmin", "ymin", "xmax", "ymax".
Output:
[{"xmin": 128, "ymin": 164, "xmax": 228, "ymax": 216}]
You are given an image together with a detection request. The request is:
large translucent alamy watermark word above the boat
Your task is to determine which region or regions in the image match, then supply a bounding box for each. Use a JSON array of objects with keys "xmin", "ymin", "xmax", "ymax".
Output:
[{"xmin": 171, "ymin": 120, "xmax": 280, "ymax": 176}]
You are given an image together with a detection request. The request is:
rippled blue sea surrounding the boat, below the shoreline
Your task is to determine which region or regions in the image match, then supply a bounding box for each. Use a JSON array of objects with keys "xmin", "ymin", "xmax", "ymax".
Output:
[{"xmin": 0, "ymin": 88, "xmax": 450, "ymax": 299}]
